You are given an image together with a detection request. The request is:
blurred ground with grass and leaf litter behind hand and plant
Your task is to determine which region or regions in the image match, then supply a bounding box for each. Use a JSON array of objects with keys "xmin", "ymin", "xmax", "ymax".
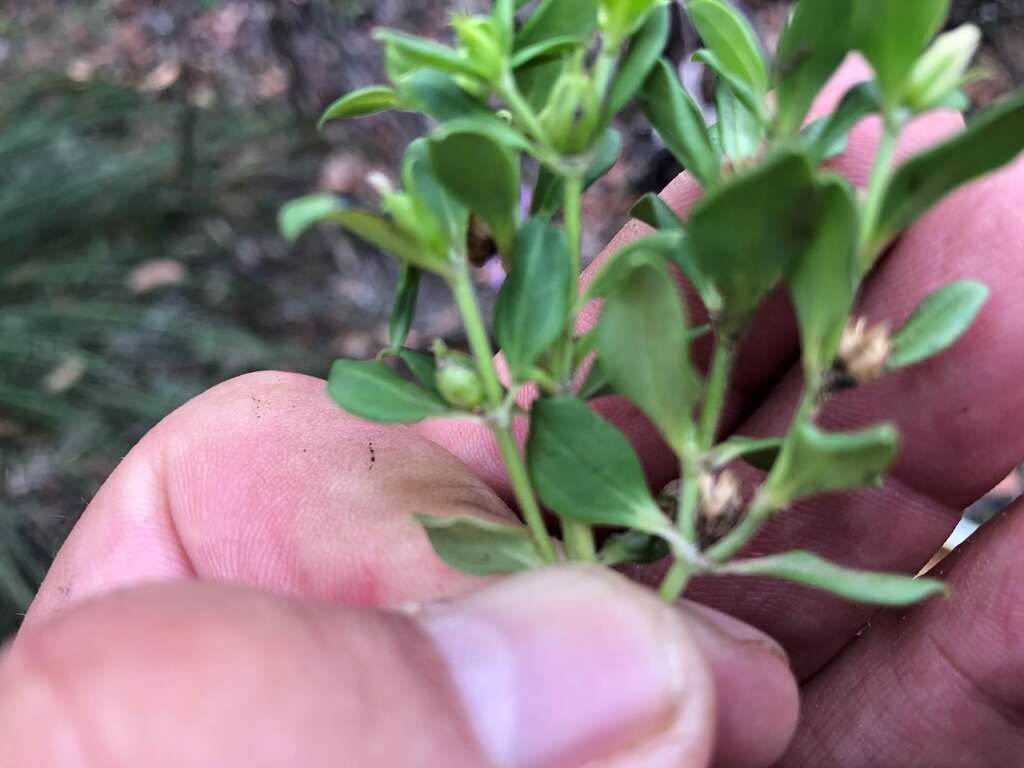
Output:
[{"xmin": 0, "ymin": 0, "xmax": 1024, "ymax": 638}]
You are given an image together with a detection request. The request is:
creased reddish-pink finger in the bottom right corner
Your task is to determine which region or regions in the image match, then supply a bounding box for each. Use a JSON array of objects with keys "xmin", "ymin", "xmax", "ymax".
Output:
[{"xmin": 780, "ymin": 502, "xmax": 1024, "ymax": 768}]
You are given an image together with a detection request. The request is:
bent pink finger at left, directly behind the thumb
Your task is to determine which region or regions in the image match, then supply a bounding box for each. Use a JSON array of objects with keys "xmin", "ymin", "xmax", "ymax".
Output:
[{"xmin": 27, "ymin": 373, "xmax": 514, "ymax": 624}]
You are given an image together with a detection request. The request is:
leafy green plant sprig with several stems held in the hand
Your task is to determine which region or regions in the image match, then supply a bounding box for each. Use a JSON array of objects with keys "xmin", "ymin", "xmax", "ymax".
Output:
[{"xmin": 281, "ymin": 0, "xmax": 1024, "ymax": 605}]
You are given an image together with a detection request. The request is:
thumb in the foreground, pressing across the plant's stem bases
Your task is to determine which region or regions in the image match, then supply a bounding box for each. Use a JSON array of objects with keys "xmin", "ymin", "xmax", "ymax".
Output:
[{"xmin": 0, "ymin": 567, "xmax": 790, "ymax": 768}]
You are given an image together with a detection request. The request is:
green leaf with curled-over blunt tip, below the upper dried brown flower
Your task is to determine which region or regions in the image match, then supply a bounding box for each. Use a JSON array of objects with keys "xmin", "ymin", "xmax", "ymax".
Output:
[{"xmin": 764, "ymin": 422, "xmax": 899, "ymax": 508}]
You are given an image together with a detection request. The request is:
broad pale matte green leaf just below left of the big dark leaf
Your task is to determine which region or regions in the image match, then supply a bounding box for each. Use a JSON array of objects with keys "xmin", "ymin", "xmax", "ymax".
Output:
[{"xmin": 598, "ymin": 265, "xmax": 698, "ymax": 450}]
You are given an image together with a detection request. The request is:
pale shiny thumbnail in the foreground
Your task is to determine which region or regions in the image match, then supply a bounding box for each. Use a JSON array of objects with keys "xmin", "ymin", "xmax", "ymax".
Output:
[{"xmin": 417, "ymin": 566, "xmax": 714, "ymax": 768}]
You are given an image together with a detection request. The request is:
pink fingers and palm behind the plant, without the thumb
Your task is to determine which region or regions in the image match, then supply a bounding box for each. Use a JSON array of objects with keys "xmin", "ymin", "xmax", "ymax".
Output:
[{"xmin": 6, "ymin": 57, "xmax": 1024, "ymax": 768}]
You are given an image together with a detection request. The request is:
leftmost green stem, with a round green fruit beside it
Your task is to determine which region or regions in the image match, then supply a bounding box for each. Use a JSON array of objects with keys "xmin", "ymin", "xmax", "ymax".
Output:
[{"xmin": 452, "ymin": 268, "xmax": 557, "ymax": 562}]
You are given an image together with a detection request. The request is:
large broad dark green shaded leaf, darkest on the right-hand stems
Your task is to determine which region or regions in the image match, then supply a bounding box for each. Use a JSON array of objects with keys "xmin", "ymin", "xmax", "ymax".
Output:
[{"xmin": 689, "ymin": 152, "xmax": 815, "ymax": 335}]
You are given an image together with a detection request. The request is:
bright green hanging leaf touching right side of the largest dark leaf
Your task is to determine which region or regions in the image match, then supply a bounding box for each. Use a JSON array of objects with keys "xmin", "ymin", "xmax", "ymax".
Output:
[{"xmin": 786, "ymin": 176, "xmax": 860, "ymax": 381}]
